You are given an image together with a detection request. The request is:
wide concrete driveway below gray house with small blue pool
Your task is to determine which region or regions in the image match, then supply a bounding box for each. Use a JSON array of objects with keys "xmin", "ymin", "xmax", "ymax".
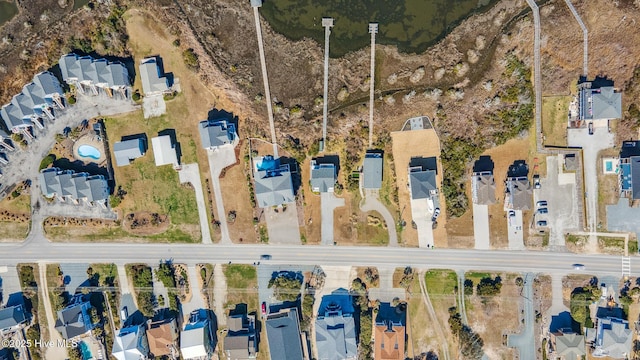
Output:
[{"xmin": 264, "ymin": 204, "xmax": 300, "ymax": 245}]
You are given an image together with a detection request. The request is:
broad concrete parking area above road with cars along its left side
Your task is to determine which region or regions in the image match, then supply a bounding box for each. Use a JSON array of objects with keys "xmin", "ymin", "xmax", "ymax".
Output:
[{"xmin": 533, "ymin": 156, "xmax": 580, "ymax": 249}]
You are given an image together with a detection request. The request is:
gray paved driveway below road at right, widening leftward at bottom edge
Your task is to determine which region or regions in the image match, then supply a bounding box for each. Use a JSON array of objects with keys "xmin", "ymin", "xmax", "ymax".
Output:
[{"xmin": 507, "ymin": 273, "xmax": 536, "ymax": 360}]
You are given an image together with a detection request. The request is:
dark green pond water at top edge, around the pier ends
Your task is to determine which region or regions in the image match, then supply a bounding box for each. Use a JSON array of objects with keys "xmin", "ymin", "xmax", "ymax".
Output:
[{"xmin": 260, "ymin": 0, "xmax": 496, "ymax": 57}]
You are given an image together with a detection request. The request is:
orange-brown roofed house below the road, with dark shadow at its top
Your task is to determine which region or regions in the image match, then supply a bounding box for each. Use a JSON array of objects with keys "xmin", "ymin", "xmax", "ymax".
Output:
[{"xmin": 374, "ymin": 303, "xmax": 407, "ymax": 360}]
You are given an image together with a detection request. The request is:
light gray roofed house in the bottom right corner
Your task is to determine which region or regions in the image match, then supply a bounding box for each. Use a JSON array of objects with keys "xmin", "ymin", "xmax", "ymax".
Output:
[{"xmin": 594, "ymin": 317, "xmax": 633, "ymax": 359}]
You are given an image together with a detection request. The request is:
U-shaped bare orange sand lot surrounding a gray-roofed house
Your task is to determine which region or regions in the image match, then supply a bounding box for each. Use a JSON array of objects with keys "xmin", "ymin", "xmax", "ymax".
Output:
[{"xmin": 391, "ymin": 129, "xmax": 448, "ymax": 247}]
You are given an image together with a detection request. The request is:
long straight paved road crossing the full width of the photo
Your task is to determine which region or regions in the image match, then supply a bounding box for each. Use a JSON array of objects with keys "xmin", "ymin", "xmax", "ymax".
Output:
[{"xmin": 0, "ymin": 242, "xmax": 640, "ymax": 278}]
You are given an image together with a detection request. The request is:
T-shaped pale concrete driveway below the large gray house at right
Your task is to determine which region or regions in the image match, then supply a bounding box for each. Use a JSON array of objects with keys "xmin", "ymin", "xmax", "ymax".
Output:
[{"xmin": 567, "ymin": 127, "xmax": 615, "ymax": 243}]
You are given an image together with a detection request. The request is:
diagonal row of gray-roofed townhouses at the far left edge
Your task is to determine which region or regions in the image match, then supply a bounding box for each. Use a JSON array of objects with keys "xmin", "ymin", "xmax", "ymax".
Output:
[{"xmin": 0, "ymin": 71, "xmax": 63, "ymax": 129}]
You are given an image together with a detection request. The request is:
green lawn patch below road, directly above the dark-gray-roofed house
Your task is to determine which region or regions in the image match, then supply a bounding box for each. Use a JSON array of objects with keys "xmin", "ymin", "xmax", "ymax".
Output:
[{"xmin": 223, "ymin": 264, "xmax": 258, "ymax": 312}]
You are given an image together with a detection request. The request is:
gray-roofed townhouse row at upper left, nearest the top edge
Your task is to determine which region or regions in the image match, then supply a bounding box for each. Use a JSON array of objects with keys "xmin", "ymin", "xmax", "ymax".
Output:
[{"xmin": 59, "ymin": 54, "xmax": 131, "ymax": 88}]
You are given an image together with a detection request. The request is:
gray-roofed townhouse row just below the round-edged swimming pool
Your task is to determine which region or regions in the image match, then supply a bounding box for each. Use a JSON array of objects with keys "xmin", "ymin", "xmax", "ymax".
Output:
[{"xmin": 38, "ymin": 168, "xmax": 109, "ymax": 202}]
